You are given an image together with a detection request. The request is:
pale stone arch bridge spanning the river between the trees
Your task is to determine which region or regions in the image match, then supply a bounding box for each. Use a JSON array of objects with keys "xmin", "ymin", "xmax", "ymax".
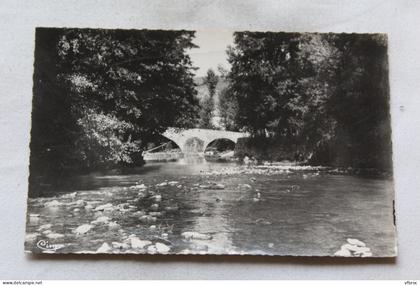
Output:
[{"xmin": 162, "ymin": 128, "xmax": 249, "ymax": 153}]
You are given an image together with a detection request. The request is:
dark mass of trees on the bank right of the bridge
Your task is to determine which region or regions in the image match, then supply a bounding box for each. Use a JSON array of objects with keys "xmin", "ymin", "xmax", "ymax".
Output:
[{"xmin": 220, "ymin": 32, "xmax": 391, "ymax": 170}]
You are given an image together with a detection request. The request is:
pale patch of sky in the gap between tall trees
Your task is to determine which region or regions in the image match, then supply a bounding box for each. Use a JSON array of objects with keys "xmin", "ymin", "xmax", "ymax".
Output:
[{"xmin": 188, "ymin": 30, "xmax": 233, "ymax": 77}]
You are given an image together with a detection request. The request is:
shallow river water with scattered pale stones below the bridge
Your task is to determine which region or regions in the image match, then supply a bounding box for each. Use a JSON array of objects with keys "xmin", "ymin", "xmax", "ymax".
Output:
[{"xmin": 25, "ymin": 159, "xmax": 395, "ymax": 256}]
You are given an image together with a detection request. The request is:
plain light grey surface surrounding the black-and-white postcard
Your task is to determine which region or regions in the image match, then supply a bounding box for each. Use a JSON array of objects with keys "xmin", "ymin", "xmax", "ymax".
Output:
[{"xmin": 0, "ymin": 0, "xmax": 420, "ymax": 279}]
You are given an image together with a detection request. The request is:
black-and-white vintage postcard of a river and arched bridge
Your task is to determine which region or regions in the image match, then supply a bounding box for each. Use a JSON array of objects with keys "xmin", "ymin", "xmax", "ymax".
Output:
[{"xmin": 25, "ymin": 28, "xmax": 397, "ymax": 257}]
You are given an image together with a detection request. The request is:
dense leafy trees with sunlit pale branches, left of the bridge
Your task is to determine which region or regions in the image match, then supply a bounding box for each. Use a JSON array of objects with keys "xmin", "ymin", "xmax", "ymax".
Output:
[{"xmin": 31, "ymin": 28, "xmax": 198, "ymax": 176}]
